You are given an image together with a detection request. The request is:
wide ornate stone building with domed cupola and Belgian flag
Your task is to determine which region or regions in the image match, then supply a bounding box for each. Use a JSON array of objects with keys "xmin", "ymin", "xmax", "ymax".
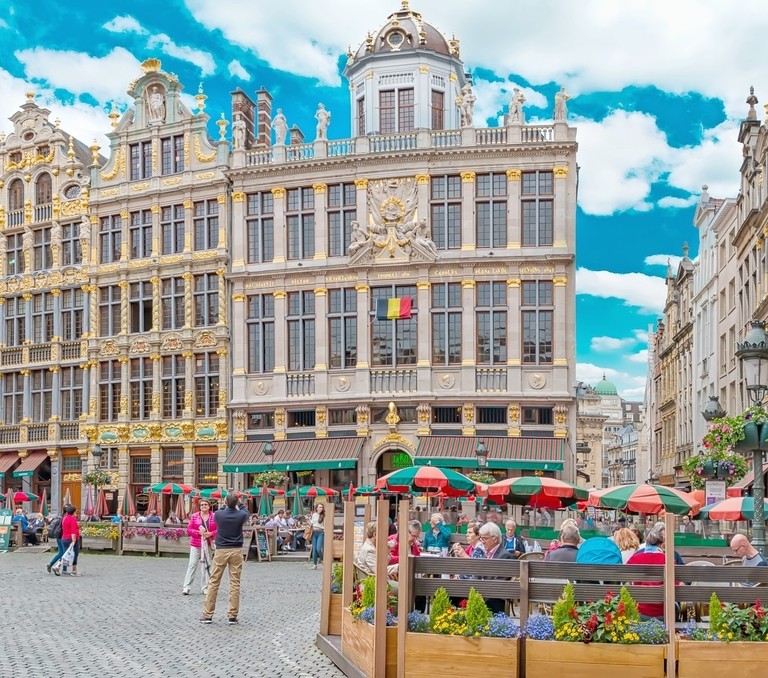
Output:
[{"xmin": 224, "ymin": 2, "xmax": 576, "ymax": 486}]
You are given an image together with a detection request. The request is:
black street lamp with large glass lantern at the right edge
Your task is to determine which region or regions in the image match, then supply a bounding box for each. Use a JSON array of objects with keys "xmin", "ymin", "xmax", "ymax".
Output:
[{"xmin": 736, "ymin": 320, "xmax": 768, "ymax": 554}]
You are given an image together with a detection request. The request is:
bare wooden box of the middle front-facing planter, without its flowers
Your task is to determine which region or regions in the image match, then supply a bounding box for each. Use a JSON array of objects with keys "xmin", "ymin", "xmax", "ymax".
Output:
[{"xmin": 525, "ymin": 639, "xmax": 664, "ymax": 678}]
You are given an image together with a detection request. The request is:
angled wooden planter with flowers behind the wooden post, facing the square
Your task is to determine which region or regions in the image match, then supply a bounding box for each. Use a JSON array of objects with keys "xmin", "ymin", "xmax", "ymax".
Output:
[{"xmin": 341, "ymin": 577, "xmax": 397, "ymax": 678}]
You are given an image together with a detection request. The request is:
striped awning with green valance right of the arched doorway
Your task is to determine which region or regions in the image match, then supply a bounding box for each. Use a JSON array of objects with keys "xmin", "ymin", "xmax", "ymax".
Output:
[{"xmin": 414, "ymin": 436, "xmax": 565, "ymax": 471}]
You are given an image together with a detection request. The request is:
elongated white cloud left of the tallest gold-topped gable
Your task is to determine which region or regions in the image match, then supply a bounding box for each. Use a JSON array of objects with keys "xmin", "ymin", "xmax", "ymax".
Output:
[{"xmin": 14, "ymin": 47, "xmax": 141, "ymax": 103}]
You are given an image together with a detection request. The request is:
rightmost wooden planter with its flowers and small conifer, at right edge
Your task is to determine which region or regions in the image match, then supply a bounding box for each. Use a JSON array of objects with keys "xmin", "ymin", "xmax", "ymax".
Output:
[{"xmin": 677, "ymin": 593, "xmax": 768, "ymax": 678}]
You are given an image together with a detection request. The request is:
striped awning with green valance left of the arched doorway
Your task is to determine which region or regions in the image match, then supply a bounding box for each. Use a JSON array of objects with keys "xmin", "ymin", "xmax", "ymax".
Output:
[{"xmin": 222, "ymin": 436, "xmax": 365, "ymax": 473}]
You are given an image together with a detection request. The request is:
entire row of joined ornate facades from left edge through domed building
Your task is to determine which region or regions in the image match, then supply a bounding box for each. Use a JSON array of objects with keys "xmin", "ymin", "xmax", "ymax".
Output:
[{"xmin": 0, "ymin": 2, "xmax": 577, "ymax": 511}]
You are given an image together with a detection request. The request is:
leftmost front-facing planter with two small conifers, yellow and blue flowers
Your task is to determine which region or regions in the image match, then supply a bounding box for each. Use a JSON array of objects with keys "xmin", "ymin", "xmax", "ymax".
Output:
[{"xmin": 405, "ymin": 587, "xmax": 520, "ymax": 678}]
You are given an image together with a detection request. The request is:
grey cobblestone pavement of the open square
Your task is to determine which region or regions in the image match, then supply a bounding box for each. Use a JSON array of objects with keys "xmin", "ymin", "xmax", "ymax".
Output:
[{"xmin": 0, "ymin": 551, "xmax": 343, "ymax": 678}]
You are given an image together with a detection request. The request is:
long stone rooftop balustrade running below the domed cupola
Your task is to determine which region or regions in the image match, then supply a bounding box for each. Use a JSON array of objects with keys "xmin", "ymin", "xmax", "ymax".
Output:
[{"xmin": 242, "ymin": 125, "xmax": 576, "ymax": 167}]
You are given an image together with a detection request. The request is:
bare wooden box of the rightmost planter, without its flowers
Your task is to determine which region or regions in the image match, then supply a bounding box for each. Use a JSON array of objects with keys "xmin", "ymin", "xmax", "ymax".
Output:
[{"xmin": 677, "ymin": 640, "xmax": 768, "ymax": 678}]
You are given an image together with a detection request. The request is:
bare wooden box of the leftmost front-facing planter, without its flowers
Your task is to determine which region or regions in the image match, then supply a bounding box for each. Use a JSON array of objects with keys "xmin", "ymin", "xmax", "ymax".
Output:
[{"xmin": 405, "ymin": 633, "xmax": 520, "ymax": 678}]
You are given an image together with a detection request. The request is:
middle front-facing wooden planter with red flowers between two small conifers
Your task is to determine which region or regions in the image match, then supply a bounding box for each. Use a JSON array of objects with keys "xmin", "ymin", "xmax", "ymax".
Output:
[{"xmin": 525, "ymin": 584, "xmax": 667, "ymax": 678}]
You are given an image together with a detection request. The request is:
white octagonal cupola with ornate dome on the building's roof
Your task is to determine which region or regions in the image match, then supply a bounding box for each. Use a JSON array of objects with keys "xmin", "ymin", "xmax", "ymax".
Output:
[{"xmin": 344, "ymin": 0, "xmax": 467, "ymax": 136}]
